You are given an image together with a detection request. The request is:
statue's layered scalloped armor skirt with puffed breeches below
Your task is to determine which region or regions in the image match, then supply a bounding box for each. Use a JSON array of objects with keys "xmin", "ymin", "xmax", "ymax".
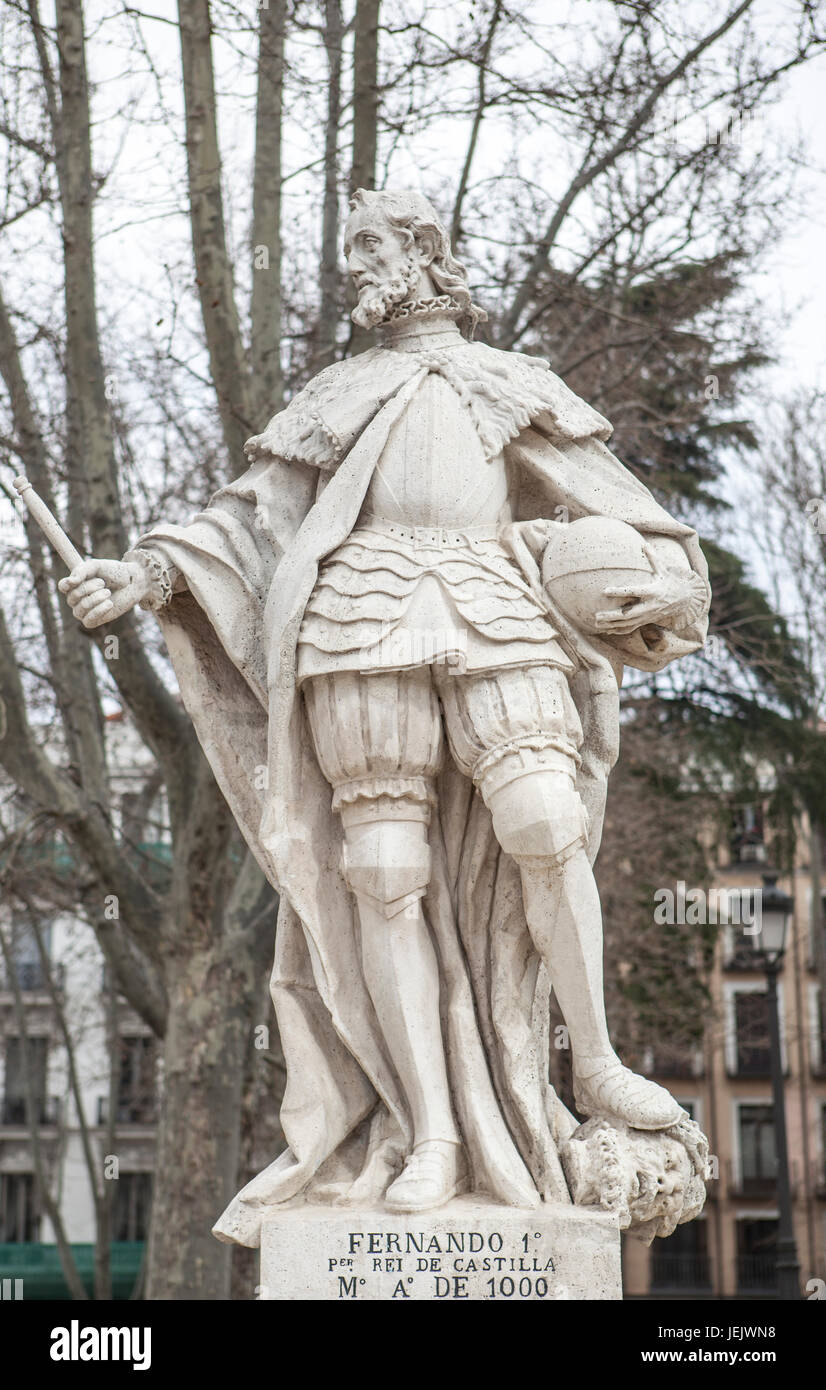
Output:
[{"xmin": 298, "ymin": 518, "xmax": 583, "ymax": 810}]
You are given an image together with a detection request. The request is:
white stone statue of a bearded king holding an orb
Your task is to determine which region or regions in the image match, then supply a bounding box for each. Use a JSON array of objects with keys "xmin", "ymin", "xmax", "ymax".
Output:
[{"xmin": 61, "ymin": 190, "xmax": 709, "ymax": 1267}]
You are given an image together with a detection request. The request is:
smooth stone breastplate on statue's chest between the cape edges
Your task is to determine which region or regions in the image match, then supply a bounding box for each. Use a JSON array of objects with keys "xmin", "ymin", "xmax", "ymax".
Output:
[{"xmin": 362, "ymin": 373, "xmax": 510, "ymax": 527}]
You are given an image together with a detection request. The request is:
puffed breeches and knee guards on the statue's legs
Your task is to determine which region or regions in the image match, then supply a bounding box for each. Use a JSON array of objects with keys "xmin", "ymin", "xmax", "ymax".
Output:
[{"xmin": 303, "ymin": 666, "xmax": 587, "ymax": 917}]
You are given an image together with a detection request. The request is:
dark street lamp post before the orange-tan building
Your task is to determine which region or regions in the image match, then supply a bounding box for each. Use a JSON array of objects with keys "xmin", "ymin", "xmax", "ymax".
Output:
[{"xmin": 750, "ymin": 873, "xmax": 800, "ymax": 1300}]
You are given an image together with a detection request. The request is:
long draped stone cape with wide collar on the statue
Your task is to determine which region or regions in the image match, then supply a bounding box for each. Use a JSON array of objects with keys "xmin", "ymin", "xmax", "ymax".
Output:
[{"xmin": 139, "ymin": 342, "xmax": 706, "ymax": 1245}]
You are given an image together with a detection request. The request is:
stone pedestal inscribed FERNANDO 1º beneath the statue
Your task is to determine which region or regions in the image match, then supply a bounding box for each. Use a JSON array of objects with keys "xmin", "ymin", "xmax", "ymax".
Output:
[{"xmin": 257, "ymin": 1197, "xmax": 622, "ymax": 1302}]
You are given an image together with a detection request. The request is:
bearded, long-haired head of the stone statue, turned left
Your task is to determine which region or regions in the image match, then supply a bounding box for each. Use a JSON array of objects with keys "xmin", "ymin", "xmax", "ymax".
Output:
[{"xmin": 345, "ymin": 188, "xmax": 487, "ymax": 338}]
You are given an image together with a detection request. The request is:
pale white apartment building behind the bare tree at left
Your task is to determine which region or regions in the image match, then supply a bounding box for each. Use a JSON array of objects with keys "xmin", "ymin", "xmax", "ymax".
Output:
[{"xmin": 0, "ymin": 717, "xmax": 164, "ymax": 1298}]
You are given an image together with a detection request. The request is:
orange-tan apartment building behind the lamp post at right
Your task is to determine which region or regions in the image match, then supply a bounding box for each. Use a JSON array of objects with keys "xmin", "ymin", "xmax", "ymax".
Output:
[{"xmin": 623, "ymin": 816, "xmax": 826, "ymax": 1300}]
